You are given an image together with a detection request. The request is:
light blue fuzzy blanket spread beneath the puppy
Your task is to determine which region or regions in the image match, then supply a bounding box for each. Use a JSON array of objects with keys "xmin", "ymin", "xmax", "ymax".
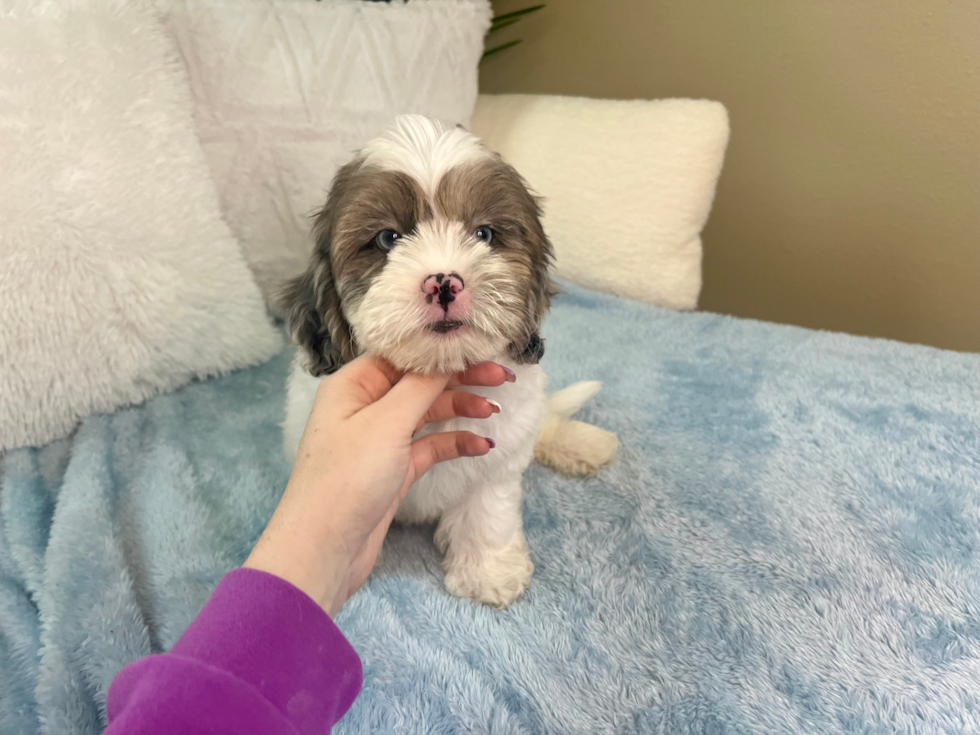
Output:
[{"xmin": 0, "ymin": 288, "xmax": 980, "ymax": 734}]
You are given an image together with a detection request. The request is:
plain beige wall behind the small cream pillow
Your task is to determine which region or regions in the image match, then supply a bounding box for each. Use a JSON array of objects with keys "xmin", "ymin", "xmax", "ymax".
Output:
[{"xmin": 481, "ymin": 0, "xmax": 980, "ymax": 351}]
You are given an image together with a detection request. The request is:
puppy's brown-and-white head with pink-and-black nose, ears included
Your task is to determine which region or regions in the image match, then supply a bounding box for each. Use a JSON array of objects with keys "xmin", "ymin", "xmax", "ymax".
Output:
[{"xmin": 282, "ymin": 115, "xmax": 552, "ymax": 375}]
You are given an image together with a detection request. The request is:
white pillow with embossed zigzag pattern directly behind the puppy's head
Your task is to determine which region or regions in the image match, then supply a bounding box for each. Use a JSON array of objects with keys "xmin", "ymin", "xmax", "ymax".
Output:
[{"xmin": 156, "ymin": 0, "xmax": 490, "ymax": 306}]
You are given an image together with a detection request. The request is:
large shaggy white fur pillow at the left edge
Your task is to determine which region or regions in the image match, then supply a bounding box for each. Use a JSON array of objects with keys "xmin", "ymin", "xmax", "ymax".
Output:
[{"xmin": 0, "ymin": 0, "xmax": 282, "ymax": 452}]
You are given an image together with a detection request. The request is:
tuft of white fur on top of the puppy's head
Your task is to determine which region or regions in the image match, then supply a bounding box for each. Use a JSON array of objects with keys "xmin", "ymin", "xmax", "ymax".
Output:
[{"xmin": 361, "ymin": 115, "xmax": 490, "ymax": 196}]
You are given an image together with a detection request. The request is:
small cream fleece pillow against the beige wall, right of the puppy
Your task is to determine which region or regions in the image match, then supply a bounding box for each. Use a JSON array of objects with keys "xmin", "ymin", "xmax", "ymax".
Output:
[{"xmin": 473, "ymin": 95, "xmax": 728, "ymax": 309}]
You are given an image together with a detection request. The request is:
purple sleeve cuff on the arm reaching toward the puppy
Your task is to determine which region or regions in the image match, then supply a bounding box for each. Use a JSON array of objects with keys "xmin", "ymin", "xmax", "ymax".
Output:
[{"xmin": 105, "ymin": 569, "xmax": 362, "ymax": 735}]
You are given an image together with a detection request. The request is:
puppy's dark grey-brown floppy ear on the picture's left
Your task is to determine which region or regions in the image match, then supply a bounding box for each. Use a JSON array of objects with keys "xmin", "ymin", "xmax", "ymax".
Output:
[{"xmin": 277, "ymin": 160, "xmax": 361, "ymax": 376}]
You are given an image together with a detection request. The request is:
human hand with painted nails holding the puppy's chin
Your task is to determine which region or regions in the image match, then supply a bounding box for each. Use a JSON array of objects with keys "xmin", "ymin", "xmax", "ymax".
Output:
[{"xmin": 244, "ymin": 356, "xmax": 514, "ymax": 617}]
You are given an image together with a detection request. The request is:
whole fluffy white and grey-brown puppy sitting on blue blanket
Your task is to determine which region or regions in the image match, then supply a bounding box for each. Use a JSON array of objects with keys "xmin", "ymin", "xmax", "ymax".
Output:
[{"xmin": 280, "ymin": 115, "xmax": 617, "ymax": 607}]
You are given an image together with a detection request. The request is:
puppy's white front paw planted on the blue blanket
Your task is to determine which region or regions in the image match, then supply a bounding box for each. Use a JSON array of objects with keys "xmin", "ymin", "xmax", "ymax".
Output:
[{"xmin": 446, "ymin": 537, "xmax": 534, "ymax": 609}]
